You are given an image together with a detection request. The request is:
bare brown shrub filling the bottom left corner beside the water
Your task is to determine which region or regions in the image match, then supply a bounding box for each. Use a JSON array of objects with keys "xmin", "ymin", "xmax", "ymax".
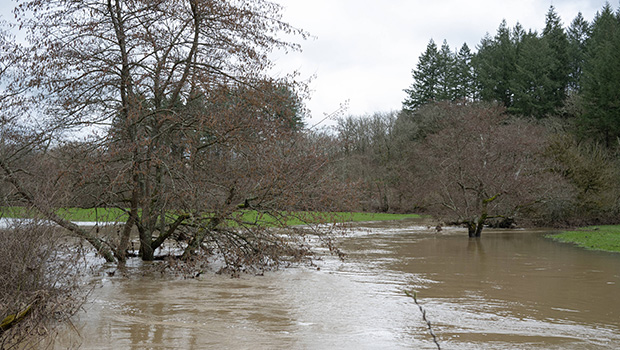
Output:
[{"xmin": 0, "ymin": 221, "xmax": 85, "ymax": 349}]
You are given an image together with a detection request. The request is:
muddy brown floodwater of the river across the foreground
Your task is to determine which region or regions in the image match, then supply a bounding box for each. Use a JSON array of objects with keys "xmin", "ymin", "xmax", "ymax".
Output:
[{"xmin": 56, "ymin": 220, "xmax": 620, "ymax": 349}]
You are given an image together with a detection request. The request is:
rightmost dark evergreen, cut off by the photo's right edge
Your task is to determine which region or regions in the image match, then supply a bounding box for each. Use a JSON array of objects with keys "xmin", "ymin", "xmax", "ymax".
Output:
[{"xmin": 579, "ymin": 4, "xmax": 620, "ymax": 146}]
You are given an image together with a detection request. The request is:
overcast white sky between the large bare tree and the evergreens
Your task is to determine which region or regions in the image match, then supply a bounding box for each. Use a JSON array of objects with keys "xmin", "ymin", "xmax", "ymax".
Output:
[{"xmin": 273, "ymin": 0, "xmax": 618, "ymax": 125}]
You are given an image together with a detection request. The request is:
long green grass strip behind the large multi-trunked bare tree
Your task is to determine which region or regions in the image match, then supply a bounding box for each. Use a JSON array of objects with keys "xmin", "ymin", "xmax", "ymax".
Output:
[{"xmin": 0, "ymin": 207, "xmax": 420, "ymax": 226}]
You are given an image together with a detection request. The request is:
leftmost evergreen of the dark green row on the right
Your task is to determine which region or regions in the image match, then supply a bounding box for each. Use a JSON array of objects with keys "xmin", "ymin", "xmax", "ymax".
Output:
[{"xmin": 403, "ymin": 39, "xmax": 440, "ymax": 111}]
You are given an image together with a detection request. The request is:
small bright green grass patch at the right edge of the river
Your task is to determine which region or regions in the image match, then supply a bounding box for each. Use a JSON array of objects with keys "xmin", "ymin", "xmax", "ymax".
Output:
[{"xmin": 547, "ymin": 225, "xmax": 620, "ymax": 253}]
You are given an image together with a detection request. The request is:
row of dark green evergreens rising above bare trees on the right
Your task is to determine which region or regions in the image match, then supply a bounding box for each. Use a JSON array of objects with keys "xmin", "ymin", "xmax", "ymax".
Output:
[{"xmin": 403, "ymin": 4, "xmax": 620, "ymax": 147}]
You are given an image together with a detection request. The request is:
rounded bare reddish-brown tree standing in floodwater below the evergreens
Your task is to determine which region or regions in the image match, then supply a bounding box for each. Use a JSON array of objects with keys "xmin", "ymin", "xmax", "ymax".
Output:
[{"xmin": 410, "ymin": 103, "xmax": 558, "ymax": 237}]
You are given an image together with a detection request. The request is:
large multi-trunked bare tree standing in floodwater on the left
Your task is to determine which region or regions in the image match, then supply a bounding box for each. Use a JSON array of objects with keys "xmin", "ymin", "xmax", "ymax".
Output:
[{"xmin": 0, "ymin": 0, "xmax": 348, "ymax": 268}]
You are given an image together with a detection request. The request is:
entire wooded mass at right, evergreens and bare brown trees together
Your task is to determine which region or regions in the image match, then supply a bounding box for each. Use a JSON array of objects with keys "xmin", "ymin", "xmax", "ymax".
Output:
[{"xmin": 338, "ymin": 5, "xmax": 620, "ymax": 236}]
